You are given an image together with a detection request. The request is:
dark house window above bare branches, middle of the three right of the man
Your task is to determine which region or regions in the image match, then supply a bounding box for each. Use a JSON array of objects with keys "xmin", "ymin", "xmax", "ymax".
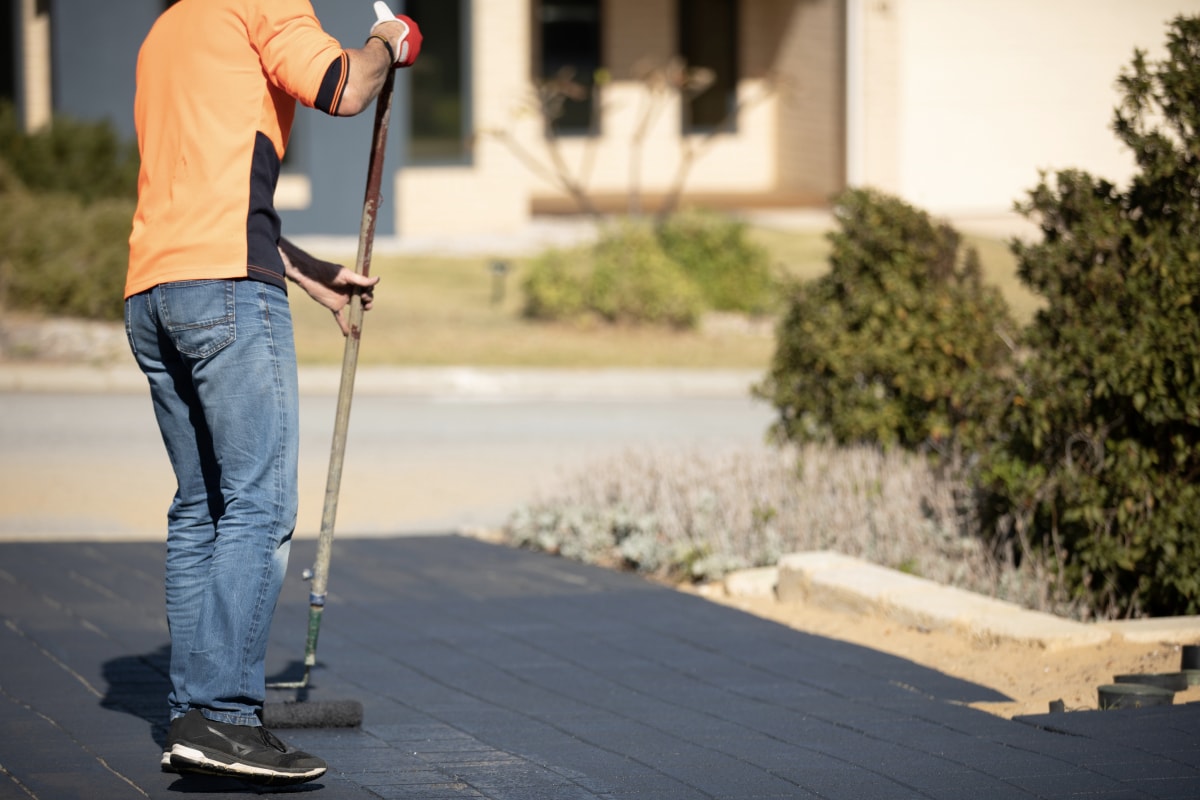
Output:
[{"xmin": 535, "ymin": 0, "xmax": 601, "ymax": 133}]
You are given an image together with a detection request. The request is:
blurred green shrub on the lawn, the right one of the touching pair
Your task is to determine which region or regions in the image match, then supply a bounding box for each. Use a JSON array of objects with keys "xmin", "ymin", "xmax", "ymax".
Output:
[{"xmin": 658, "ymin": 211, "xmax": 779, "ymax": 314}]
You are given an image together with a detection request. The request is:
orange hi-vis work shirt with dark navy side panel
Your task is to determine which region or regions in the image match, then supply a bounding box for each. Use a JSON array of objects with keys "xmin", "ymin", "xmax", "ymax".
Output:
[{"xmin": 125, "ymin": 0, "xmax": 349, "ymax": 297}]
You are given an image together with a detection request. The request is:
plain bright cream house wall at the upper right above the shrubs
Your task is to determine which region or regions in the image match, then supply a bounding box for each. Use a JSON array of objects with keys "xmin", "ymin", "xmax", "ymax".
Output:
[{"xmin": 850, "ymin": 0, "xmax": 1200, "ymax": 213}]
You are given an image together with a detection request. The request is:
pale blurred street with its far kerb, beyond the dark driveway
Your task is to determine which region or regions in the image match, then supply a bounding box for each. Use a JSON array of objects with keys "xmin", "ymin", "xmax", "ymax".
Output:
[{"xmin": 0, "ymin": 363, "xmax": 772, "ymax": 541}]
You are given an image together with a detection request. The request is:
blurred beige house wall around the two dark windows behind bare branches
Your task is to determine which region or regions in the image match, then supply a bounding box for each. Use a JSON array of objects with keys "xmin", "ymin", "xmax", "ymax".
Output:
[{"xmin": 395, "ymin": 0, "xmax": 845, "ymax": 235}]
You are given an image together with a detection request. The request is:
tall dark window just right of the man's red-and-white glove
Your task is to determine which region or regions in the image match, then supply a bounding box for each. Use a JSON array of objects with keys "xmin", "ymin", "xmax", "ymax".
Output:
[{"xmin": 404, "ymin": 0, "xmax": 469, "ymax": 162}]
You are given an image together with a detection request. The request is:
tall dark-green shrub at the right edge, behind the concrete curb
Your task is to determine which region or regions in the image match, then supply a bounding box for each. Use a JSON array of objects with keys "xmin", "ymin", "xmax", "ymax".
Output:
[{"xmin": 983, "ymin": 17, "xmax": 1200, "ymax": 614}]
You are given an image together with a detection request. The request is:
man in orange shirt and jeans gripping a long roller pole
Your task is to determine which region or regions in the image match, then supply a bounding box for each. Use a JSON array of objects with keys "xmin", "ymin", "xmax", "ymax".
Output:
[{"xmin": 125, "ymin": 0, "xmax": 421, "ymax": 783}]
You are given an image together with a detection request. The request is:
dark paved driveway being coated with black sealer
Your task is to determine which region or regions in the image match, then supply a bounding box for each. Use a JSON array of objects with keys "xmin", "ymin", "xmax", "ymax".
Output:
[{"xmin": 0, "ymin": 536, "xmax": 1200, "ymax": 800}]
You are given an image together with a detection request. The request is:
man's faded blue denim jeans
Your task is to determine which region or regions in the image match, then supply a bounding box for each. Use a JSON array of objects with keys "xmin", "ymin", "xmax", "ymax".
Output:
[{"xmin": 125, "ymin": 281, "xmax": 299, "ymax": 726}]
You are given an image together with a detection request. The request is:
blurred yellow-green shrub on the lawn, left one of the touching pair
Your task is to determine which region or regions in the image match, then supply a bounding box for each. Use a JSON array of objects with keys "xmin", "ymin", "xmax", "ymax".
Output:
[{"xmin": 523, "ymin": 223, "xmax": 703, "ymax": 327}]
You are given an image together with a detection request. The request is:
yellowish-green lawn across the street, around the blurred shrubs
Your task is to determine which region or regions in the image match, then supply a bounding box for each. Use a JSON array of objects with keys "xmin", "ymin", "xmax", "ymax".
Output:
[{"xmin": 292, "ymin": 229, "xmax": 1036, "ymax": 369}]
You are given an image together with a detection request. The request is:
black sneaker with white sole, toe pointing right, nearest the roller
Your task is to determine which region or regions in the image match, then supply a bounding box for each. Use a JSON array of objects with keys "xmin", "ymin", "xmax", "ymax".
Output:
[{"xmin": 170, "ymin": 709, "xmax": 325, "ymax": 786}]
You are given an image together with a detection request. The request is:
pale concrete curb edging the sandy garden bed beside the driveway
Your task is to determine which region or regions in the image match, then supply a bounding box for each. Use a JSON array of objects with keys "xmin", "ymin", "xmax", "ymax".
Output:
[{"xmin": 725, "ymin": 551, "xmax": 1200, "ymax": 650}]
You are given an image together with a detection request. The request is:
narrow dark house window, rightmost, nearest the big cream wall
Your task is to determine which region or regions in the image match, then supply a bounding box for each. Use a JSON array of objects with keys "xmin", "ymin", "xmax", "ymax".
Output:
[{"xmin": 679, "ymin": 0, "xmax": 738, "ymax": 132}]
